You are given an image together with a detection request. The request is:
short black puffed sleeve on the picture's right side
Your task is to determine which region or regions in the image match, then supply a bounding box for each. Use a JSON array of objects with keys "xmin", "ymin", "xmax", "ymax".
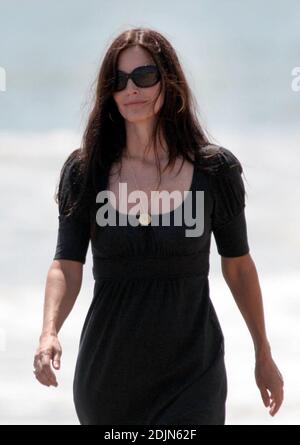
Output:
[{"xmin": 210, "ymin": 147, "xmax": 250, "ymax": 257}]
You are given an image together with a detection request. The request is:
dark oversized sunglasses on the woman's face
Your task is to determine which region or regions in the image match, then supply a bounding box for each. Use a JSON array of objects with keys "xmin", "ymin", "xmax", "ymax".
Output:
[{"xmin": 114, "ymin": 65, "xmax": 161, "ymax": 91}]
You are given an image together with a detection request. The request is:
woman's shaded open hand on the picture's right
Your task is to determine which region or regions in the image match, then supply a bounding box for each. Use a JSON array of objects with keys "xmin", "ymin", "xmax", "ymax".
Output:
[{"xmin": 255, "ymin": 354, "xmax": 284, "ymax": 416}]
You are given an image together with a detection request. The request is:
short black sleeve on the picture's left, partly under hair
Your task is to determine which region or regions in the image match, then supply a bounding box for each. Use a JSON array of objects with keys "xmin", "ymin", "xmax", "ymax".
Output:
[{"xmin": 53, "ymin": 153, "xmax": 90, "ymax": 264}]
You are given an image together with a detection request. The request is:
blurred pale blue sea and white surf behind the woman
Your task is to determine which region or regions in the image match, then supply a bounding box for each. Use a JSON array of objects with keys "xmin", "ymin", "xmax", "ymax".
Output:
[{"xmin": 0, "ymin": 0, "xmax": 300, "ymax": 425}]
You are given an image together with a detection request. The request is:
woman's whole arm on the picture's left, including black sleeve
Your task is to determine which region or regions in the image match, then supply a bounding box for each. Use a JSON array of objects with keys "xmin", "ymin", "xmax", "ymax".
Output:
[{"xmin": 33, "ymin": 150, "xmax": 90, "ymax": 386}]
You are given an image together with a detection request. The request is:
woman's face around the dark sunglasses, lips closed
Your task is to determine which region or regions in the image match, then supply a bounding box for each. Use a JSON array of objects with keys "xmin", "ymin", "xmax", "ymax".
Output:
[{"xmin": 113, "ymin": 46, "xmax": 164, "ymax": 122}]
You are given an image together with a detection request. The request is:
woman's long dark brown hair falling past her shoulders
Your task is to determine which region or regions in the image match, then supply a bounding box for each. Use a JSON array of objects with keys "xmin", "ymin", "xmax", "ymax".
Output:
[{"xmin": 55, "ymin": 27, "xmax": 241, "ymax": 238}]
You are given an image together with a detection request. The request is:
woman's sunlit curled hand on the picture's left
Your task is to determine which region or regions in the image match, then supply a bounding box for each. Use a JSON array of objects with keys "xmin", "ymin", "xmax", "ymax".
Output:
[{"xmin": 33, "ymin": 334, "xmax": 62, "ymax": 386}]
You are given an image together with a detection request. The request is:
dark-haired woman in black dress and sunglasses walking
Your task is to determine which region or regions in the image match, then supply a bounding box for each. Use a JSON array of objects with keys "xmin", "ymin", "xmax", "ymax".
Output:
[{"xmin": 34, "ymin": 28, "xmax": 283, "ymax": 425}]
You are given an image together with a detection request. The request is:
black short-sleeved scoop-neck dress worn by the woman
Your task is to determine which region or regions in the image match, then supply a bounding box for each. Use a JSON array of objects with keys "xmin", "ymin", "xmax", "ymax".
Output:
[{"xmin": 54, "ymin": 147, "xmax": 249, "ymax": 425}]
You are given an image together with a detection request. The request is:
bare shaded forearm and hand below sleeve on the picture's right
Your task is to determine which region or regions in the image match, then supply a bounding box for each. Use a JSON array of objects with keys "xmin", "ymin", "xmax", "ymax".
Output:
[{"xmin": 221, "ymin": 253, "xmax": 284, "ymax": 416}]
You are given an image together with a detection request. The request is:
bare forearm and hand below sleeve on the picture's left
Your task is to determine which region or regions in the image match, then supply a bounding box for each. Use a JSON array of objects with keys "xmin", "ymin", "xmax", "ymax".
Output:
[{"xmin": 33, "ymin": 259, "xmax": 83, "ymax": 386}]
